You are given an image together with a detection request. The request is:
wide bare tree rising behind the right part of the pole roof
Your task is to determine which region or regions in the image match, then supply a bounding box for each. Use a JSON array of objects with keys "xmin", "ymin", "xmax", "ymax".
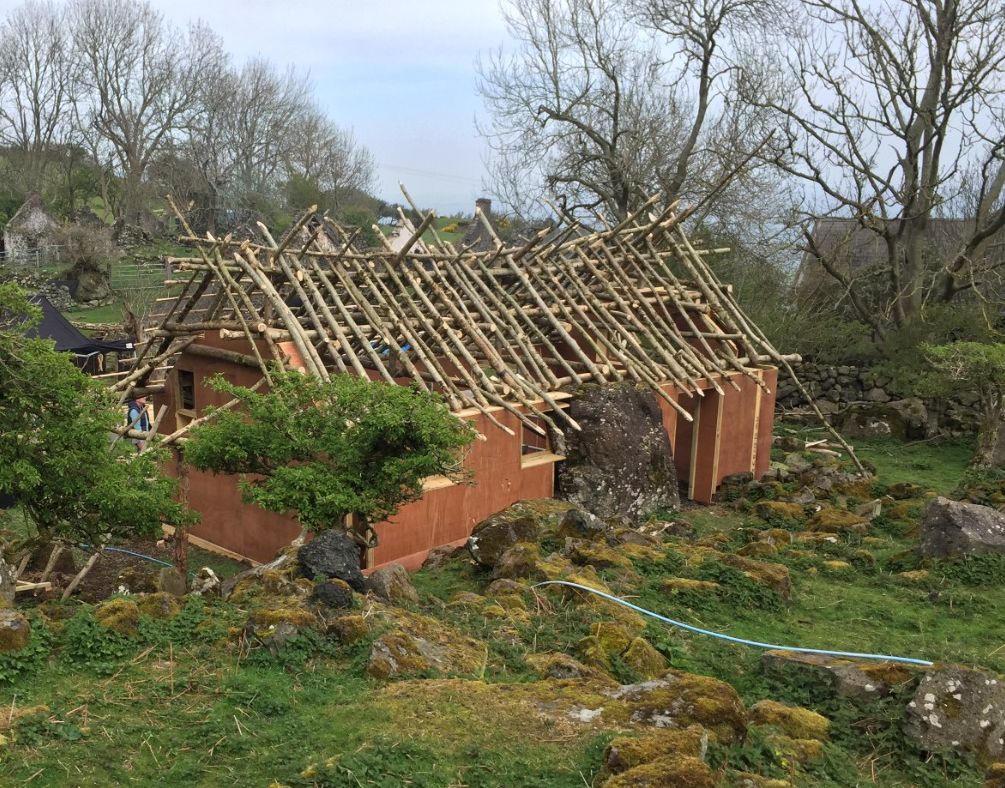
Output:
[{"xmin": 478, "ymin": 0, "xmax": 774, "ymax": 223}]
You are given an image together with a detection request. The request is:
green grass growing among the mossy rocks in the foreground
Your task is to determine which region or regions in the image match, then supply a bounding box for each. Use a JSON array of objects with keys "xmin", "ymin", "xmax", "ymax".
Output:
[{"xmin": 0, "ymin": 427, "xmax": 1005, "ymax": 786}]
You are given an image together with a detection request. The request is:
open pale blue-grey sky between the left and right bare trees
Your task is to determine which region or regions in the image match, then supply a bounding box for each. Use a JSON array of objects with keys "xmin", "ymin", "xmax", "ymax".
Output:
[{"xmin": 0, "ymin": 0, "xmax": 506, "ymax": 213}]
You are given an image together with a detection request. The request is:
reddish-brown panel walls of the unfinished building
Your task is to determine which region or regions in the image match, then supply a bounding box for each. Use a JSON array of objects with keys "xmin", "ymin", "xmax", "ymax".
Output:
[{"xmin": 155, "ymin": 336, "xmax": 777, "ymax": 569}]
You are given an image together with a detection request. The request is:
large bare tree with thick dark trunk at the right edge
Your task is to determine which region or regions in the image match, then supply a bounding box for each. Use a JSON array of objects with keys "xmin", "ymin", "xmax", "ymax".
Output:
[{"xmin": 751, "ymin": 0, "xmax": 1005, "ymax": 338}]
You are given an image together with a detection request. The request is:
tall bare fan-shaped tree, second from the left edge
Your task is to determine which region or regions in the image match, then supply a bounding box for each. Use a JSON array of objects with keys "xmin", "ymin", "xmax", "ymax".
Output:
[{"xmin": 72, "ymin": 0, "xmax": 224, "ymax": 222}]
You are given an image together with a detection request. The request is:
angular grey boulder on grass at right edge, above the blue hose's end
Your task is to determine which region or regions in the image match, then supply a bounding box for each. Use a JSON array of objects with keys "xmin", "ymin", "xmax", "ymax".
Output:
[{"xmin": 919, "ymin": 498, "xmax": 1005, "ymax": 558}]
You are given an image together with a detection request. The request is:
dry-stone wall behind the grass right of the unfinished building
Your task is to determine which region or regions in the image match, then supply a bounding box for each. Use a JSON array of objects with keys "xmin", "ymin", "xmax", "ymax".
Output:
[{"xmin": 776, "ymin": 362, "xmax": 979, "ymax": 440}]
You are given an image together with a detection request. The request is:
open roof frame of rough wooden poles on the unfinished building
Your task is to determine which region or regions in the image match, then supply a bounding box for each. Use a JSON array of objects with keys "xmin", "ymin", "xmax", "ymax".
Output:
[{"xmin": 117, "ymin": 193, "xmax": 808, "ymax": 442}]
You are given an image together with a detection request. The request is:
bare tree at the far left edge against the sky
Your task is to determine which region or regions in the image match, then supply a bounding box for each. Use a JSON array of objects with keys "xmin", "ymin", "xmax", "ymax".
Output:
[{"xmin": 0, "ymin": 0, "xmax": 72, "ymax": 192}]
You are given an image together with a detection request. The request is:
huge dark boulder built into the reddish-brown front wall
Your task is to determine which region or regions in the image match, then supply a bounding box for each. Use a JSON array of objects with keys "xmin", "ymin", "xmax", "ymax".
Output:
[{"xmin": 557, "ymin": 384, "xmax": 680, "ymax": 519}]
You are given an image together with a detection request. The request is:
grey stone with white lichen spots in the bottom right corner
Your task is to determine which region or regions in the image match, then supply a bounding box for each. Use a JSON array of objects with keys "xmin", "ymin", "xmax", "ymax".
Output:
[{"xmin": 905, "ymin": 665, "xmax": 1005, "ymax": 763}]
